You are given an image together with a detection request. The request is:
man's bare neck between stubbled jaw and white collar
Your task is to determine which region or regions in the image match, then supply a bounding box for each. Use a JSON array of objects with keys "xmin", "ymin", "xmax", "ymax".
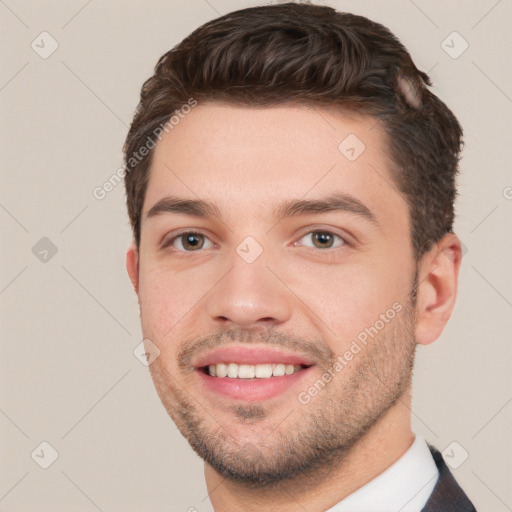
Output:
[{"xmin": 205, "ymin": 392, "xmax": 414, "ymax": 512}]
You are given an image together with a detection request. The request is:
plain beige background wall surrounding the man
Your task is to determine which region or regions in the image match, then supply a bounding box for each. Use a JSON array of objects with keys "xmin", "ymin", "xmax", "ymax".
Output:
[{"xmin": 0, "ymin": 0, "xmax": 512, "ymax": 512}]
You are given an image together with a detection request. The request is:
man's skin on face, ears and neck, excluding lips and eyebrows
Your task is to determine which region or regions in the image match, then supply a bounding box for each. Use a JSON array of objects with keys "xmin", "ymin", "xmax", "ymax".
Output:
[{"xmin": 127, "ymin": 103, "xmax": 461, "ymax": 511}]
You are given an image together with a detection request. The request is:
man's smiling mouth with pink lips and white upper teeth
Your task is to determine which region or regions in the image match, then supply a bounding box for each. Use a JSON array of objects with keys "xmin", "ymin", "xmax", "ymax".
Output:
[{"xmin": 194, "ymin": 347, "xmax": 314, "ymax": 402}]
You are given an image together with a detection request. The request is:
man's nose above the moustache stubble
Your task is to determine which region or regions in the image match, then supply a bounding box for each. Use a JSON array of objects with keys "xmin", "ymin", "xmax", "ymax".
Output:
[{"xmin": 207, "ymin": 250, "xmax": 292, "ymax": 329}]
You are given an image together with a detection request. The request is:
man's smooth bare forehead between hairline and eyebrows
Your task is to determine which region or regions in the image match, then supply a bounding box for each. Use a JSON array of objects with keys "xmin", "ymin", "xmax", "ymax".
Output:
[{"xmin": 144, "ymin": 103, "xmax": 405, "ymax": 222}]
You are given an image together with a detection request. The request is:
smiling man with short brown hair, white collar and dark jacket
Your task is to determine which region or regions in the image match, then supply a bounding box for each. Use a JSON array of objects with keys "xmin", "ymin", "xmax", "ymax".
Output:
[{"xmin": 124, "ymin": 3, "xmax": 474, "ymax": 512}]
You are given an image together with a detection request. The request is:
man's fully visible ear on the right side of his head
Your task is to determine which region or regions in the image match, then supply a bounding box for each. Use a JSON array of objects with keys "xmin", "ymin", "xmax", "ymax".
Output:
[{"xmin": 416, "ymin": 233, "xmax": 462, "ymax": 345}]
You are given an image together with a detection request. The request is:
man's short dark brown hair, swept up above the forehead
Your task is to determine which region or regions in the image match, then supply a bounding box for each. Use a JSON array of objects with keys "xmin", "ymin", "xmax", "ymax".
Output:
[{"xmin": 124, "ymin": 2, "xmax": 463, "ymax": 258}]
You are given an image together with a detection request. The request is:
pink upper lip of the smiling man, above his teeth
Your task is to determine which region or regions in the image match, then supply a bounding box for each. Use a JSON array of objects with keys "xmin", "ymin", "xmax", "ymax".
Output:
[{"xmin": 192, "ymin": 345, "xmax": 314, "ymax": 368}]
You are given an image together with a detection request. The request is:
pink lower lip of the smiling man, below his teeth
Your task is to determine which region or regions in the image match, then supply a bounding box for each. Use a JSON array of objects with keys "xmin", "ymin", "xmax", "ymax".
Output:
[{"xmin": 196, "ymin": 367, "xmax": 310, "ymax": 402}]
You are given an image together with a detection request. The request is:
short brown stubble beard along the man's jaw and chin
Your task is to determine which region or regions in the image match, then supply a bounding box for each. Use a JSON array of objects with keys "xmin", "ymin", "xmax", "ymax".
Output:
[{"xmin": 144, "ymin": 304, "xmax": 416, "ymax": 488}]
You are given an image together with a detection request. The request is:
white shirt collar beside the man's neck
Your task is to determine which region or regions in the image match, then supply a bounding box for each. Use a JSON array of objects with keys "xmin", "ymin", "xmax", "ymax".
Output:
[{"xmin": 326, "ymin": 435, "xmax": 439, "ymax": 512}]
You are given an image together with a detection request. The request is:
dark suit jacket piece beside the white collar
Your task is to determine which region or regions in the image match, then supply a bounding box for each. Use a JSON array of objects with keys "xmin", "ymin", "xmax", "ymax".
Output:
[{"xmin": 421, "ymin": 445, "xmax": 476, "ymax": 512}]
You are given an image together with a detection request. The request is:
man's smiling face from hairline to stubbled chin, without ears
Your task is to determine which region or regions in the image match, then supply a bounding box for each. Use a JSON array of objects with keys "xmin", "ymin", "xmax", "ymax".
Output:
[{"xmin": 130, "ymin": 103, "xmax": 416, "ymax": 485}]
